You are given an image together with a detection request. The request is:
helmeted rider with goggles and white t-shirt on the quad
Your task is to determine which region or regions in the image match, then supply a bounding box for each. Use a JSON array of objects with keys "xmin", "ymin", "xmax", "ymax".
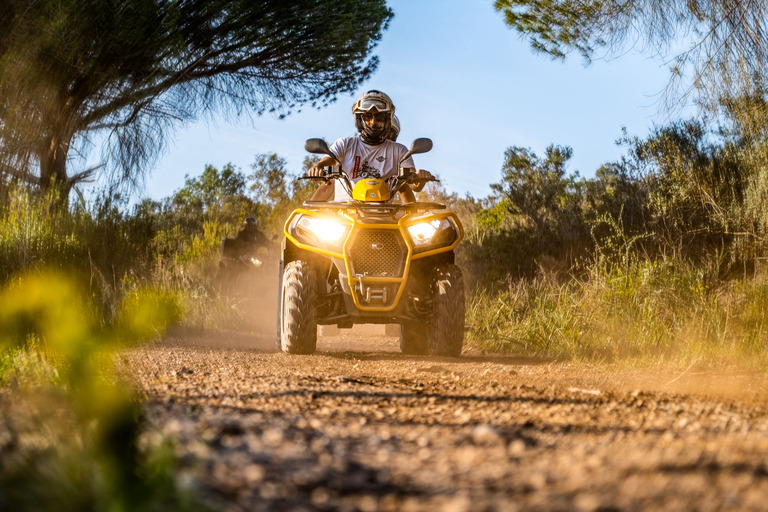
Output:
[{"xmin": 307, "ymin": 90, "xmax": 432, "ymax": 202}]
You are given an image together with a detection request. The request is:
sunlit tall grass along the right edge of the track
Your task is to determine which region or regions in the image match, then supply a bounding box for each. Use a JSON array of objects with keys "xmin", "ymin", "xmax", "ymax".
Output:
[{"xmin": 467, "ymin": 259, "xmax": 768, "ymax": 369}]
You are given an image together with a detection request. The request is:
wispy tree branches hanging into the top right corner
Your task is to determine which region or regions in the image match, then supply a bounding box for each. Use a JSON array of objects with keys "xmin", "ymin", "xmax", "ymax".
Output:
[{"xmin": 494, "ymin": 0, "xmax": 768, "ymax": 112}]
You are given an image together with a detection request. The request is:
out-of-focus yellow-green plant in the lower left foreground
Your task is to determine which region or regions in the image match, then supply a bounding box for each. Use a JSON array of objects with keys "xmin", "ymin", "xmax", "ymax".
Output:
[{"xmin": 0, "ymin": 272, "xmax": 203, "ymax": 511}]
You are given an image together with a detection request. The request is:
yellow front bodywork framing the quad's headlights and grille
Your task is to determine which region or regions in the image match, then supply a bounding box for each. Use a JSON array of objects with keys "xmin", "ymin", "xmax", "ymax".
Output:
[{"xmin": 284, "ymin": 205, "xmax": 464, "ymax": 311}]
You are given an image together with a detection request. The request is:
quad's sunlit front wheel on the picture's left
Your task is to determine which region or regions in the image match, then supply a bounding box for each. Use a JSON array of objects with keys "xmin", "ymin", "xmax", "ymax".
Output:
[{"xmin": 280, "ymin": 261, "xmax": 317, "ymax": 354}]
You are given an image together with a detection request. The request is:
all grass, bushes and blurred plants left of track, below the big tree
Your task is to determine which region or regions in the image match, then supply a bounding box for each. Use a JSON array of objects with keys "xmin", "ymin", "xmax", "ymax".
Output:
[{"xmin": 0, "ymin": 154, "xmax": 312, "ymax": 511}]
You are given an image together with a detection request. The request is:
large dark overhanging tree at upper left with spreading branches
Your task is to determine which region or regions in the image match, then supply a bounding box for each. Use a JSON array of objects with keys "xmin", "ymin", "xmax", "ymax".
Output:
[{"xmin": 0, "ymin": 0, "xmax": 392, "ymax": 197}]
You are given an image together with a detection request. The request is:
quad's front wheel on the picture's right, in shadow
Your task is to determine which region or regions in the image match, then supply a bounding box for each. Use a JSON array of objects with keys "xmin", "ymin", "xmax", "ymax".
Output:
[{"xmin": 427, "ymin": 263, "xmax": 464, "ymax": 357}]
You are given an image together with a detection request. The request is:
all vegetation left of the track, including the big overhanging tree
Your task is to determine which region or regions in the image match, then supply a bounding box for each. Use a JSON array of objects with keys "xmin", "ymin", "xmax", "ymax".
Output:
[{"xmin": 0, "ymin": 0, "xmax": 393, "ymax": 504}]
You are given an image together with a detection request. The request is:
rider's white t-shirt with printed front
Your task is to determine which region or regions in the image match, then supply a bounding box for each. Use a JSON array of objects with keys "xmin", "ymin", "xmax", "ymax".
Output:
[{"xmin": 331, "ymin": 137, "xmax": 415, "ymax": 201}]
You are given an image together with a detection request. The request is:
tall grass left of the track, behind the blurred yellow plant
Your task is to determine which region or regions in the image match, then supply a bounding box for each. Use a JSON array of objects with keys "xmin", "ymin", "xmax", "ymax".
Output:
[{"xmin": 0, "ymin": 187, "xmax": 260, "ymax": 329}]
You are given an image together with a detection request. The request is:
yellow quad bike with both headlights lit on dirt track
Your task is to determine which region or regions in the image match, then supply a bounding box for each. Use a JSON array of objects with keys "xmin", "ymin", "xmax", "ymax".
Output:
[{"xmin": 277, "ymin": 139, "xmax": 464, "ymax": 357}]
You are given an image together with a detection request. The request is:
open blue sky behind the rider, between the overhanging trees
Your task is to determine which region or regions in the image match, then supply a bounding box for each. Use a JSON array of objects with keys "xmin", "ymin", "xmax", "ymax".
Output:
[{"xmin": 143, "ymin": 0, "xmax": 680, "ymax": 198}]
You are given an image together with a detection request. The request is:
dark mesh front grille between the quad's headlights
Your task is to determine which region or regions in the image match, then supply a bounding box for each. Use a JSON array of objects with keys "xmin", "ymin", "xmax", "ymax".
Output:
[{"xmin": 349, "ymin": 229, "xmax": 406, "ymax": 277}]
